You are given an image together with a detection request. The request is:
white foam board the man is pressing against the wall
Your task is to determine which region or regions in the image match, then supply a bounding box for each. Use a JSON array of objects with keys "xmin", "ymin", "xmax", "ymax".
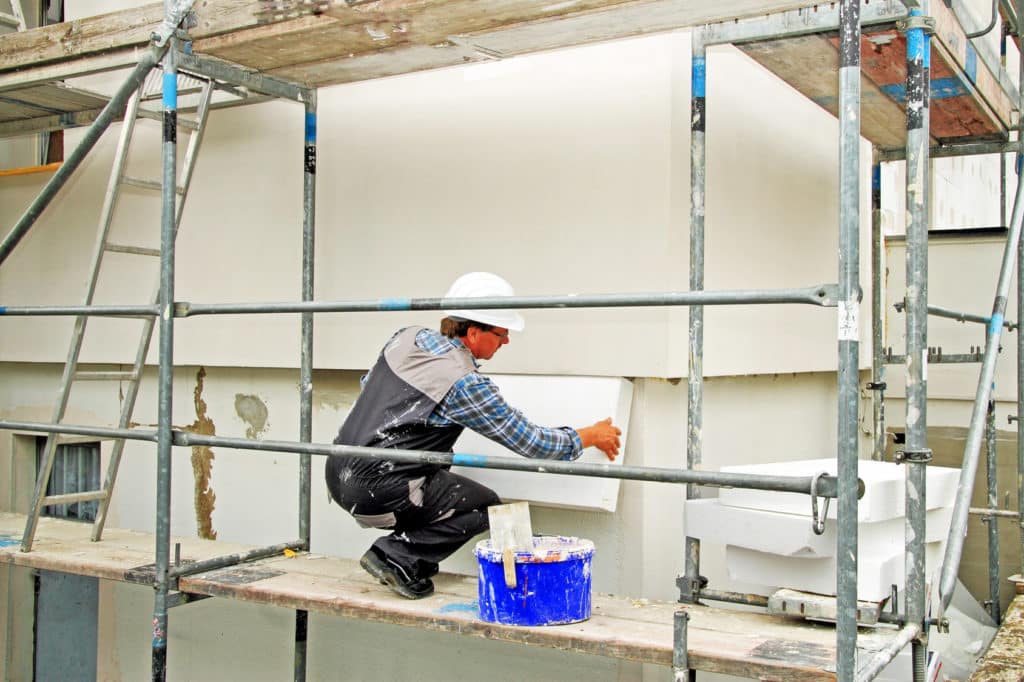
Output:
[{"xmin": 453, "ymin": 374, "xmax": 633, "ymax": 512}]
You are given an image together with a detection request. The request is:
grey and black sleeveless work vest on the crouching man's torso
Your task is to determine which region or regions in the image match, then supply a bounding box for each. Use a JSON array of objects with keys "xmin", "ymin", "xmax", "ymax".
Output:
[{"xmin": 330, "ymin": 327, "xmax": 476, "ymax": 478}]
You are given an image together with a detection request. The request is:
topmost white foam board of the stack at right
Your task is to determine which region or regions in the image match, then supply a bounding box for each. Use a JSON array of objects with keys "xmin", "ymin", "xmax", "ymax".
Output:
[{"xmin": 718, "ymin": 459, "xmax": 959, "ymax": 521}]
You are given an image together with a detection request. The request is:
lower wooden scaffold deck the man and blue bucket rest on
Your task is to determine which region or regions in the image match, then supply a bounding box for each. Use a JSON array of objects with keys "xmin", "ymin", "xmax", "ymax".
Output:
[{"xmin": 0, "ymin": 513, "xmax": 913, "ymax": 680}]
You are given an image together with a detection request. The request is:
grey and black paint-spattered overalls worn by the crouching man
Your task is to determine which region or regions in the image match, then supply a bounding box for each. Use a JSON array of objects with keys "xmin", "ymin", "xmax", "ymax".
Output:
[{"xmin": 326, "ymin": 327, "xmax": 501, "ymax": 580}]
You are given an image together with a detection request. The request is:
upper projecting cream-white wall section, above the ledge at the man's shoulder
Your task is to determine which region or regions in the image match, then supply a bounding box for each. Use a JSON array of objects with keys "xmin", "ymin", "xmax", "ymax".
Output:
[{"xmin": 0, "ymin": 34, "xmax": 869, "ymax": 377}]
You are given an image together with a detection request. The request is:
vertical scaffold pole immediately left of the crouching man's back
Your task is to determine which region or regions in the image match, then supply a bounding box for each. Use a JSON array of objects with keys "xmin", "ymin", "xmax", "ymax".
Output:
[{"xmin": 295, "ymin": 90, "xmax": 316, "ymax": 682}]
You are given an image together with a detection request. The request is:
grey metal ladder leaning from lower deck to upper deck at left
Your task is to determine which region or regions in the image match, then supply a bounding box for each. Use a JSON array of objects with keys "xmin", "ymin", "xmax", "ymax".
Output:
[{"xmin": 22, "ymin": 70, "xmax": 215, "ymax": 552}]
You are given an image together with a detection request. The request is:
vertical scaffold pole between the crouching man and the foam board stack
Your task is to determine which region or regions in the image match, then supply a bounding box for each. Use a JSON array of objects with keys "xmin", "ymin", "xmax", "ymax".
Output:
[{"xmin": 680, "ymin": 29, "xmax": 708, "ymax": 602}]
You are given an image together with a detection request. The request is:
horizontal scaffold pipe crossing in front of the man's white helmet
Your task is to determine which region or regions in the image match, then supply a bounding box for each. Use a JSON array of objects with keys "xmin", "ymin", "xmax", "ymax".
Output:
[{"xmin": 174, "ymin": 285, "xmax": 837, "ymax": 317}]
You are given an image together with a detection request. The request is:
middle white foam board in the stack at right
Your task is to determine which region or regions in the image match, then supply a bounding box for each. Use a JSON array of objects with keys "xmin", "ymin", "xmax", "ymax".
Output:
[{"xmin": 686, "ymin": 498, "xmax": 953, "ymax": 559}]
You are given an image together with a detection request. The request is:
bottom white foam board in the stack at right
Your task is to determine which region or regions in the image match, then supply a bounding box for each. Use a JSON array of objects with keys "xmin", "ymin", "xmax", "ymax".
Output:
[{"xmin": 725, "ymin": 542, "xmax": 944, "ymax": 601}]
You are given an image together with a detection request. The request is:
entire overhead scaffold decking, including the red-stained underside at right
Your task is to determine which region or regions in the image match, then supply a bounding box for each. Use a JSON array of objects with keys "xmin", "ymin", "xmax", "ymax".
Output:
[{"xmin": 0, "ymin": 0, "xmax": 1014, "ymax": 144}]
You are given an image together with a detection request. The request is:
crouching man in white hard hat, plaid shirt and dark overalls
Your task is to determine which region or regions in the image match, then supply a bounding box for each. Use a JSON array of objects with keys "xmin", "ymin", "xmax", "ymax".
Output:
[{"xmin": 326, "ymin": 272, "xmax": 622, "ymax": 599}]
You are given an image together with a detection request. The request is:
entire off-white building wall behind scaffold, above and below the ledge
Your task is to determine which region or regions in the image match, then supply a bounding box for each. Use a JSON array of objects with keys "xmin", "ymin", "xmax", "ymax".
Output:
[{"xmin": 0, "ymin": 3, "xmax": 1013, "ymax": 680}]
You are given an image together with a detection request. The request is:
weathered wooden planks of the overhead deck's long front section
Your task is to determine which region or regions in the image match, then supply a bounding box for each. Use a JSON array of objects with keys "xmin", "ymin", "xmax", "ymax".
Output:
[{"xmin": 0, "ymin": 0, "xmax": 813, "ymax": 86}]
